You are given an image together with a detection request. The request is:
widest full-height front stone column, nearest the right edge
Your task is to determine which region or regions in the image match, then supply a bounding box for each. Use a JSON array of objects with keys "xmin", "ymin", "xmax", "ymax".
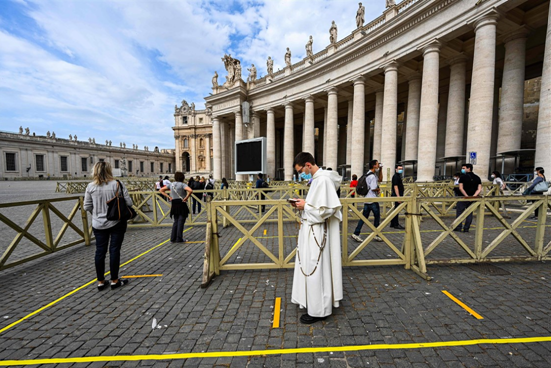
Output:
[{"xmin": 466, "ymin": 14, "xmax": 498, "ymax": 180}]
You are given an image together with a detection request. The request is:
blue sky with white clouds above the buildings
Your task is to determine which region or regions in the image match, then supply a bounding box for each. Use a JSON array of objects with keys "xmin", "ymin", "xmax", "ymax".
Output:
[{"xmin": 0, "ymin": 0, "xmax": 385, "ymax": 148}]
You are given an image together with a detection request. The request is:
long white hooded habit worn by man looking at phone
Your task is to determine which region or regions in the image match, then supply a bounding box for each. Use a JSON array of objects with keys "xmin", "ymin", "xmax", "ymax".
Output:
[{"xmin": 291, "ymin": 169, "xmax": 343, "ymax": 317}]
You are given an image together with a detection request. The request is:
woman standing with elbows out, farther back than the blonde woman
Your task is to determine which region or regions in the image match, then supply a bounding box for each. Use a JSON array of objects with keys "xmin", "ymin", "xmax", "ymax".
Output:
[{"xmin": 161, "ymin": 171, "xmax": 193, "ymax": 243}]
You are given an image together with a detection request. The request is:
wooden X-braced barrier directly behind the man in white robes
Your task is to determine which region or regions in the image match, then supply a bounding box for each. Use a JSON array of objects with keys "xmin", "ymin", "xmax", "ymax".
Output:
[{"xmin": 203, "ymin": 196, "xmax": 551, "ymax": 285}]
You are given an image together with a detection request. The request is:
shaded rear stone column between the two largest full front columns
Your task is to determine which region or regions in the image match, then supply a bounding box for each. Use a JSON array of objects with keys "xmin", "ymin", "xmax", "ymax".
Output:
[{"xmin": 444, "ymin": 55, "xmax": 467, "ymax": 157}]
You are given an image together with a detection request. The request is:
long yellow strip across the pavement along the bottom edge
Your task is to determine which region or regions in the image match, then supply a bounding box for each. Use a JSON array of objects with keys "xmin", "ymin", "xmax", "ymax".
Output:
[{"xmin": 0, "ymin": 336, "xmax": 551, "ymax": 366}]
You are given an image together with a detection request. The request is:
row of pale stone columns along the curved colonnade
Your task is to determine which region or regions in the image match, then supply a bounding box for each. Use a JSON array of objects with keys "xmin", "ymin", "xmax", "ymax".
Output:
[{"xmin": 213, "ymin": 6, "xmax": 551, "ymax": 181}]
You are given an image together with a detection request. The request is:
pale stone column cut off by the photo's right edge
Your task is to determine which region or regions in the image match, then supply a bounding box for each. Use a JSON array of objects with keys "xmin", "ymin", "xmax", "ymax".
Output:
[{"xmin": 535, "ymin": 5, "xmax": 551, "ymax": 168}]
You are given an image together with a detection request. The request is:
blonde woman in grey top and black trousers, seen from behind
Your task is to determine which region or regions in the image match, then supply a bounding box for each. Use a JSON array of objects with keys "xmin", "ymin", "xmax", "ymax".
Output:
[{"xmin": 83, "ymin": 161, "xmax": 132, "ymax": 291}]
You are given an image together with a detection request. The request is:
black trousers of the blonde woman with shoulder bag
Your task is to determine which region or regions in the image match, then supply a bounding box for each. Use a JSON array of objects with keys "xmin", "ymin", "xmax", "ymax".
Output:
[{"xmin": 93, "ymin": 221, "xmax": 127, "ymax": 281}]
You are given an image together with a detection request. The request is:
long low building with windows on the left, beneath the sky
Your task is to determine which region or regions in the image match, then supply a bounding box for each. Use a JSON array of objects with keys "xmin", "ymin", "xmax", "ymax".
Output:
[{"xmin": 0, "ymin": 128, "xmax": 175, "ymax": 180}]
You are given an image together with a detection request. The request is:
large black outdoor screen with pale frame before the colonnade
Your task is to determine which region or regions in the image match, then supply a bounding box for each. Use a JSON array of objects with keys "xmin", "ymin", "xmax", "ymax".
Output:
[{"xmin": 235, "ymin": 137, "xmax": 266, "ymax": 174}]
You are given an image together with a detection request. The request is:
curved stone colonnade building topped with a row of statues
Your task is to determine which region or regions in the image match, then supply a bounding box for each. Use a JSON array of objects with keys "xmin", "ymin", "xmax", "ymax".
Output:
[{"xmin": 201, "ymin": 0, "xmax": 551, "ymax": 182}]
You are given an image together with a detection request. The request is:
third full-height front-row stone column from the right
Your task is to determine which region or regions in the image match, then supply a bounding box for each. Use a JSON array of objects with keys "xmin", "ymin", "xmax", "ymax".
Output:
[{"xmin": 379, "ymin": 62, "xmax": 398, "ymax": 181}]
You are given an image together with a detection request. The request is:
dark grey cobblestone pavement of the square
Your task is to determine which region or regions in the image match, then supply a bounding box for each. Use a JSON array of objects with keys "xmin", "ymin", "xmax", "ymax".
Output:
[{"xmin": 0, "ymin": 183, "xmax": 551, "ymax": 368}]
